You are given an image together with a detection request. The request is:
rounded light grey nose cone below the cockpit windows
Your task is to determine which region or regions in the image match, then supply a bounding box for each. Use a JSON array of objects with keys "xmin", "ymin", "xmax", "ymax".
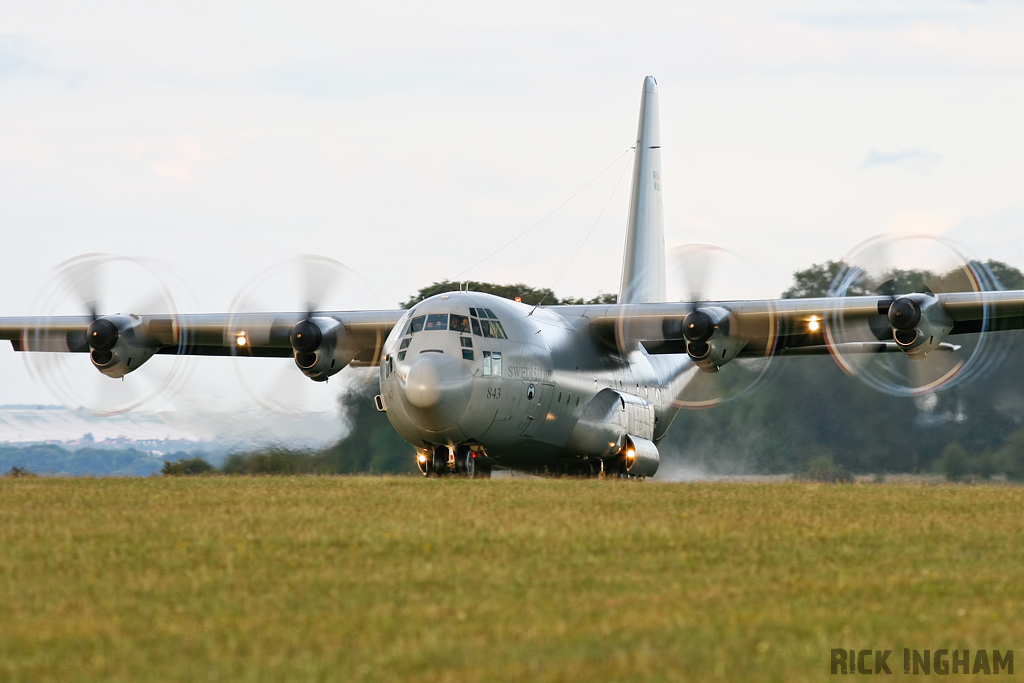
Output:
[{"xmin": 401, "ymin": 353, "xmax": 473, "ymax": 431}]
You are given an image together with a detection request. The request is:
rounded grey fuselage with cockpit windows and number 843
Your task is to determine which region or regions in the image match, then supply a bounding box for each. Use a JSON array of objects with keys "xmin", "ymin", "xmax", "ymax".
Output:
[{"xmin": 380, "ymin": 292, "xmax": 694, "ymax": 469}]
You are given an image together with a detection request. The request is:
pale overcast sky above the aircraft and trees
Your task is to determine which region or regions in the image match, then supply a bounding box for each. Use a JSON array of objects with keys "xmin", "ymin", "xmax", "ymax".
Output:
[{"xmin": 0, "ymin": 0, "xmax": 1024, "ymax": 411}]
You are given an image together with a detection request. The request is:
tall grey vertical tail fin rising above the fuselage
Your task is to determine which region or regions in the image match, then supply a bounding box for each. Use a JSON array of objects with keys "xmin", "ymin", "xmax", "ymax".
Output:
[{"xmin": 618, "ymin": 76, "xmax": 666, "ymax": 303}]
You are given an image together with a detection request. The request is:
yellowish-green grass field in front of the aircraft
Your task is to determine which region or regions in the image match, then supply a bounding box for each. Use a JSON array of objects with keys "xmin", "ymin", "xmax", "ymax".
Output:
[{"xmin": 0, "ymin": 477, "xmax": 1024, "ymax": 682}]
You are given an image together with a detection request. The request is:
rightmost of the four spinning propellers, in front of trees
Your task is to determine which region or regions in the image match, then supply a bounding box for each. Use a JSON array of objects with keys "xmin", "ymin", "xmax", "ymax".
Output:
[{"xmin": 824, "ymin": 234, "xmax": 1005, "ymax": 396}]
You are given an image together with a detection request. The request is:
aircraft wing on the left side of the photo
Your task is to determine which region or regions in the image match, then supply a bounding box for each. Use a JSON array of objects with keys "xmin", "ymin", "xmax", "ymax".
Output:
[{"xmin": 0, "ymin": 309, "xmax": 406, "ymax": 366}]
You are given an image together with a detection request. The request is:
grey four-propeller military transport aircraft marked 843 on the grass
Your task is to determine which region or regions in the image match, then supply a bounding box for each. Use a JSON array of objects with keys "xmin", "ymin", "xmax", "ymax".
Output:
[{"xmin": 0, "ymin": 77, "xmax": 1024, "ymax": 477}]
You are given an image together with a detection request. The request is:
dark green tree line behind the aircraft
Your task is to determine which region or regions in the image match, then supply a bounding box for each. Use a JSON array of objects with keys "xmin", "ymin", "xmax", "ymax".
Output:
[{"xmin": 9, "ymin": 261, "xmax": 1024, "ymax": 480}]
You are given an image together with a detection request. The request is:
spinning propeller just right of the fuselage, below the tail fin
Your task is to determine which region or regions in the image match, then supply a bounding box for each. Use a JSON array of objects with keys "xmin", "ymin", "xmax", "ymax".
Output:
[{"xmin": 667, "ymin": 244, "xmax": 777, "ymax": 409}]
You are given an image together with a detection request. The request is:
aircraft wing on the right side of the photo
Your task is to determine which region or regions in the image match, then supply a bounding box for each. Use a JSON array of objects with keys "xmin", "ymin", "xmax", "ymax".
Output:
[{"xmin": 573, "ymin": 290, "xmax": 1024, "ymax": 356}]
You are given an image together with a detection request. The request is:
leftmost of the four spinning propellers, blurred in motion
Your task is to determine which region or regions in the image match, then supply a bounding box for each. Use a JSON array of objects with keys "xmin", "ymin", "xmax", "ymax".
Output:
[{"xmin": 23, "ymin": 254, "xmax": 189, "ymax": 415}]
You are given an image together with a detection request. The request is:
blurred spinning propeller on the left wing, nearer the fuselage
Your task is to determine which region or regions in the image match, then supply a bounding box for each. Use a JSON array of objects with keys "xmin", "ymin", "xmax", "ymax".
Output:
[{"xmin": 228, "ymin": 255, "xmax": 384, "ymax": 415}]
